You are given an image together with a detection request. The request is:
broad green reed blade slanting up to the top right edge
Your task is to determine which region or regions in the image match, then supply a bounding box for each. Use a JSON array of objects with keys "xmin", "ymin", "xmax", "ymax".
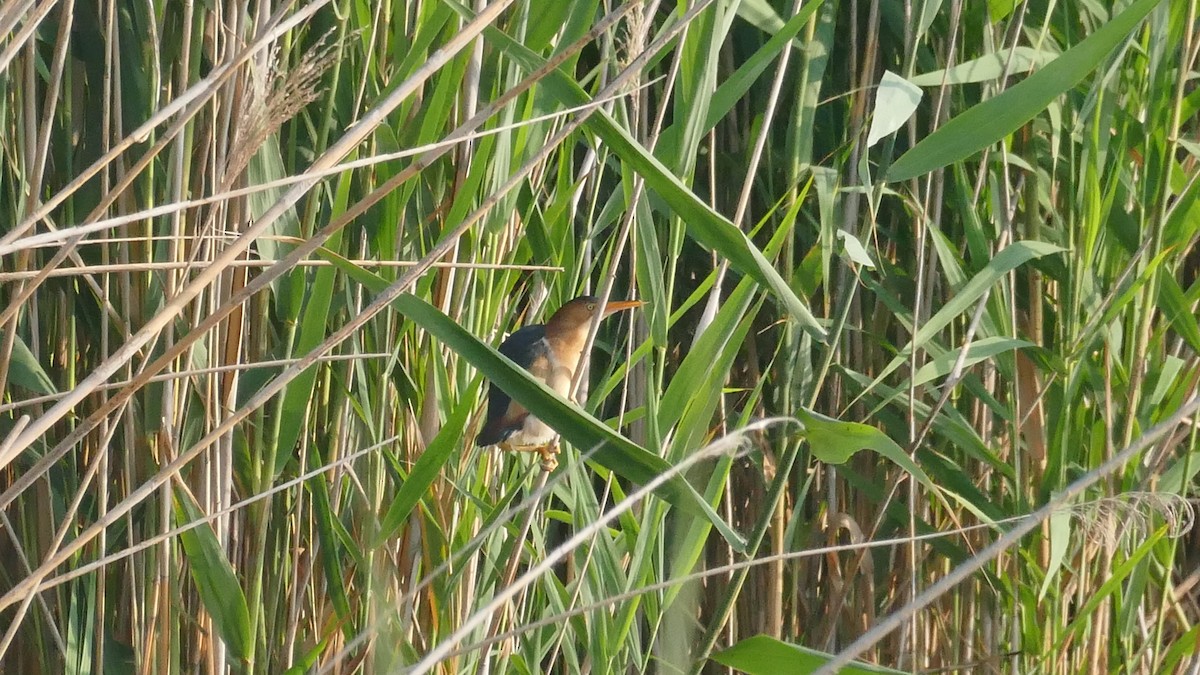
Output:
[{"xmin": 884, "ymin": 0, "xmax": 1162, "ymax": 183}]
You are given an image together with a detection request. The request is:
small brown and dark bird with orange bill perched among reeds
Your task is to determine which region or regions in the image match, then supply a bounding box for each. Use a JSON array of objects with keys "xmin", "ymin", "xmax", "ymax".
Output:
[{"xmin": 475, "ymin": 295, "xmax": 643, "ymax": 471}]
